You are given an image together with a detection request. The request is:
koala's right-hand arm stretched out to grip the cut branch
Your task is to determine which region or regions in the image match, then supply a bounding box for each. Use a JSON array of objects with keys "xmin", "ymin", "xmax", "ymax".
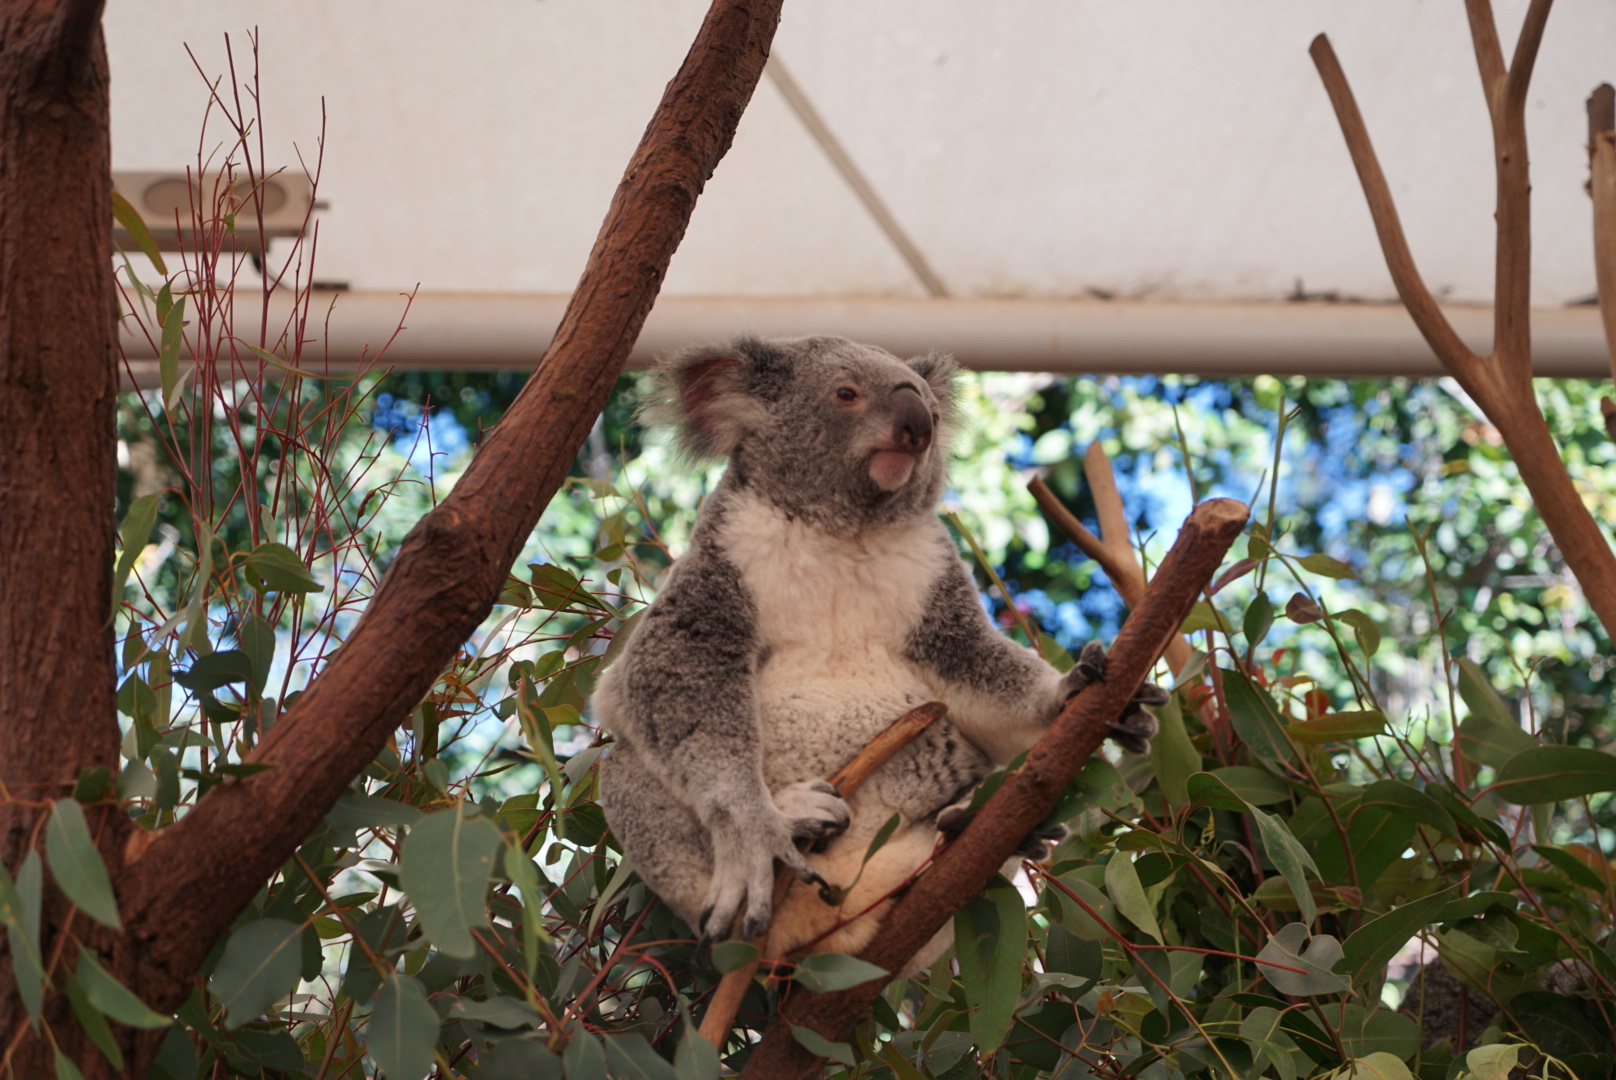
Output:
[{"xmin": 905, "ymin": 558, "xmax": 1165, "ymax": 763}]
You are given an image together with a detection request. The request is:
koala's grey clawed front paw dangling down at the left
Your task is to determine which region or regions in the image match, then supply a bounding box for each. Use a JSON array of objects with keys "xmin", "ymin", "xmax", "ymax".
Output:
[{"xmin": 696, "ymin": 800, "xmax": 845, "ymax": 952}]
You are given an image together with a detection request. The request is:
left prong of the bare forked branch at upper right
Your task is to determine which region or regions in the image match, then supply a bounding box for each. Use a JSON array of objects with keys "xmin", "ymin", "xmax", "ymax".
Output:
[{"xmin": 1307, "ymin": 34, "xmax": 1480, "ymax": 389}]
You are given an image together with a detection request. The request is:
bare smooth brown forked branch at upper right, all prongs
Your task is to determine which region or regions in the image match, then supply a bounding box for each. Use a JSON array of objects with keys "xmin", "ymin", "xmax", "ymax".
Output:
[{"xmin": 1309, "ymin": 0, "xmax": 1616, "ymax": 637}]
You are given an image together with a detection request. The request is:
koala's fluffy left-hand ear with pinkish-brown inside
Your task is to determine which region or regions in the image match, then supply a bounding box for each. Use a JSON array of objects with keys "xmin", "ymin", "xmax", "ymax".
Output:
[{"xmin": 643, "ymin": 344, "xmax": 768, "ymax": 459}]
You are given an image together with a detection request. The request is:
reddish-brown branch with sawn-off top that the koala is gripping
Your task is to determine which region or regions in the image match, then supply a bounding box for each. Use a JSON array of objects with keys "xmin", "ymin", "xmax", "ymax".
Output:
[{"xmin": 742, "ymin": 500, "xmax": 1248, "ymax": 1080}]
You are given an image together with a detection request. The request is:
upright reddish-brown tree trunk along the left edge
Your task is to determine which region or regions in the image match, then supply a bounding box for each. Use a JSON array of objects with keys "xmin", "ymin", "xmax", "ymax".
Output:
[{"xmin": 0, "ymin": 0, "xmax": 128, "ymax": 1077}]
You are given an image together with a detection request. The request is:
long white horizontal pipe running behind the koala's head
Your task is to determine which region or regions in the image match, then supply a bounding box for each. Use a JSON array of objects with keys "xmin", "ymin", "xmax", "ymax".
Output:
[{"xmin": 124, "ymin": 291, "xmax": 1610, "ymax": 386}]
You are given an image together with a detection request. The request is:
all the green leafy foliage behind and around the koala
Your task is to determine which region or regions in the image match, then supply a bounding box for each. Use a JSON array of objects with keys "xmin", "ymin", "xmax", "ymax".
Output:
[{"xmin": 12, "ymin": 37, "xmax": 1616, "ymax": 1080}]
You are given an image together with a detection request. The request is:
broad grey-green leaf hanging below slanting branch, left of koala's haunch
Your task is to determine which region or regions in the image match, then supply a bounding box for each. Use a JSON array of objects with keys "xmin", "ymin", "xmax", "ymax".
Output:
[{"xmin": 399, "ymin": 807, "xmax": 501, "ymax": 960}]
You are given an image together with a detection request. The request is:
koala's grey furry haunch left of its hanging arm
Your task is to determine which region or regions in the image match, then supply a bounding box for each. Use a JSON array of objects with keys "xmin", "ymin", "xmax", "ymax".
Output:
[{"xmin": 600, "ymin": 737, "xmax": 713, "ymax": 928}]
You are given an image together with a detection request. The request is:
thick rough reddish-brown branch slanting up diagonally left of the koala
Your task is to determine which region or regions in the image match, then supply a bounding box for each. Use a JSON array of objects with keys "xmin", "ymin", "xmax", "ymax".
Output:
[{"xmin": 112, "ymin": 0, "xmax": 781, "ymax": 1009}]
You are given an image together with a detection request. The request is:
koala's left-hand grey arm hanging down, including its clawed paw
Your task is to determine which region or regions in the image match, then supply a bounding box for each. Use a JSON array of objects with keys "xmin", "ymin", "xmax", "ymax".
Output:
[{"xmin": 601, "ymin": 545, "xmax": 847, "ymax": 938}]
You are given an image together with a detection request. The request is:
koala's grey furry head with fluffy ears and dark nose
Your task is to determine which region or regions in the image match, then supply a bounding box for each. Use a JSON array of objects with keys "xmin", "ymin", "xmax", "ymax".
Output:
[{"xmin": 648, "ymin": 338, "xmax": 953, "ymax": 534}]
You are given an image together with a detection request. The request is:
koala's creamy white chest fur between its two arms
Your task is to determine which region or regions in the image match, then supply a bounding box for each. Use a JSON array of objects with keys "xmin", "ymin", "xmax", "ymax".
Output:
[{"xmin": 721, "ymin": 498, "xmax": 955, "ymax": 787}]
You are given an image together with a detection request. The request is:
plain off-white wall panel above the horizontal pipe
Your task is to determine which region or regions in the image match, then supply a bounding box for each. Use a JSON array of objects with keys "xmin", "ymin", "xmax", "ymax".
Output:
[{"xmin": 107, "ymin": 0, "xmax": 1616, "ymax": 302}]
